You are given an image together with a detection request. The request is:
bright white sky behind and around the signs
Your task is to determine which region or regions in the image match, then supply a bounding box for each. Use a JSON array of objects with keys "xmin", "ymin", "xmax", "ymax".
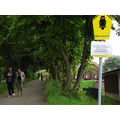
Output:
[{"xmin": 92, "ymin": 20, "xmax": 120, "ymax": 63}]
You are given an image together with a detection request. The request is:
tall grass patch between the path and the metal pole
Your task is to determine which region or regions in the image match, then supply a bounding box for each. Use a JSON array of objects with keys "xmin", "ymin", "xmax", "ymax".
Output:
[{"xmin": 45, "ymin": 79, "xmax": 97, "ymax": 105}]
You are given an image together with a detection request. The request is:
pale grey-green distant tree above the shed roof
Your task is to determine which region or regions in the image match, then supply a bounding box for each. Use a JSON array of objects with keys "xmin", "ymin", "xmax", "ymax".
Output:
[{"xmin": 103, "ymin": 56, "xmax": 120, "ymax": 72}]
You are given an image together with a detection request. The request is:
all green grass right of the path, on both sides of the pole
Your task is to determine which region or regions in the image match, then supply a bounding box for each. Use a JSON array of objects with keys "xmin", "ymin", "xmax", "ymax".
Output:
[{"xmin": 45, "ymin": 79, "xmax": 120, "ymax": 105}]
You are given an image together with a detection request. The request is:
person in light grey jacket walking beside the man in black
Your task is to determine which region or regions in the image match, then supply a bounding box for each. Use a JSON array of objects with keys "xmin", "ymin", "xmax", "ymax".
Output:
[{"xmin": 16, "ymin": 68, "xmax": 25, "ymax": 96}]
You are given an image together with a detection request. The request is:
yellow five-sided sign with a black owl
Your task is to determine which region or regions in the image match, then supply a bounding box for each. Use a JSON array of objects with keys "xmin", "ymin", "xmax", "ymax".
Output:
[{"xmin": 93, "ymin": 15, "xmax": 112, "ymax": 40}]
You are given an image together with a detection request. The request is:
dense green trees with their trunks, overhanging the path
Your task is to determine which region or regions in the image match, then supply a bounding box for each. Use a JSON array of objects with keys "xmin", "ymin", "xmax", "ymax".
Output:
[{"xmin": 0, "ymin": 15, "xmax": 116, "ymax": 91}]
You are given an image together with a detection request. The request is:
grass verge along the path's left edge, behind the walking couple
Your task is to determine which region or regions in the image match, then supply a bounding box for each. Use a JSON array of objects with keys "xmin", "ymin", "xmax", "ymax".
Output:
[{"xmin": 0, "ymin": 79, "xmax": 31, "ymax": 94}]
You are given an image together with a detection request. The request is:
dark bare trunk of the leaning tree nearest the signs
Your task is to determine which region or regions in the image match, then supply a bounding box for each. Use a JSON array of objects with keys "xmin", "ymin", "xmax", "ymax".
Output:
[{"xmin": 73, "ymin": 16, "xmax": 90, "ymax": 89}]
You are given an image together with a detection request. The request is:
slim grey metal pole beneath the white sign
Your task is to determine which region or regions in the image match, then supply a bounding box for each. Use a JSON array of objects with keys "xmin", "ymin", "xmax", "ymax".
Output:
[{"xmin": 98, "ymin": 57, "xmax": 102, "ymax": 105}]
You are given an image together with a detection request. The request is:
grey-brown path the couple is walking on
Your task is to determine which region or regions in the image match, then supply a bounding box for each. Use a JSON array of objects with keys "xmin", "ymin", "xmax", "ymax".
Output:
[{"xmin": 0, "ymin": 80, "xmax": 47, "ymax": 105}]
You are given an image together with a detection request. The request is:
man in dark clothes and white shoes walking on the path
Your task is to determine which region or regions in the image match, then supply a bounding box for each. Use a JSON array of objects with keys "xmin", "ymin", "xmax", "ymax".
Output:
[{"xmin": 5, "ymin": 67, "xmax": 15, "ymax": 97}]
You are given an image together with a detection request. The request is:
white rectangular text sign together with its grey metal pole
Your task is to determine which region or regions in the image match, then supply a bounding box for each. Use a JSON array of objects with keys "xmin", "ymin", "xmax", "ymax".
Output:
[{"xmin": 91, "ymin": 41, "xmax": 112, "ymax": 105}]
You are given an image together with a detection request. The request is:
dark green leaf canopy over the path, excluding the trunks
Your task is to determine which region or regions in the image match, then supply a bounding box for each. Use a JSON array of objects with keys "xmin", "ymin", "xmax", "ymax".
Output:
[{"xmin": 0, "ymin": 16, "xmax": 89, "ymax": 83}]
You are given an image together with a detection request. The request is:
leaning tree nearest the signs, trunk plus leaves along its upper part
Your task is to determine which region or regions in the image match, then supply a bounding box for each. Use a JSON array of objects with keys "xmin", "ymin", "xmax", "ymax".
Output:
[{"xmin": 73, "ymin": 16, "xmax": 93, "ymax": 89}]
